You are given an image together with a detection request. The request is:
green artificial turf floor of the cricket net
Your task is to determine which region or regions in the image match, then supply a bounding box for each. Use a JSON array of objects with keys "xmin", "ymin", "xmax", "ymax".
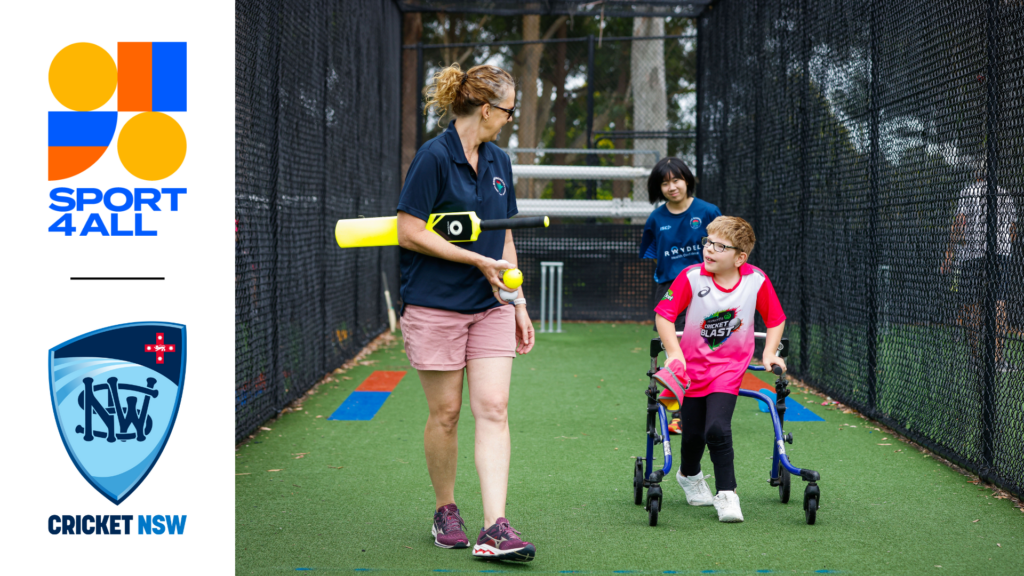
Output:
[{"xmin": 236, "ymin": 324, "xmax": 1024, "ymax": 574}]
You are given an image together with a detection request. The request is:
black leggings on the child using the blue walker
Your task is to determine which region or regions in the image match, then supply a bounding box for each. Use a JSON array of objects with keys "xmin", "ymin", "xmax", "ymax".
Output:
[{"xmin": 680, "ymin": 392, "xmax": 736, "ymax": 491}]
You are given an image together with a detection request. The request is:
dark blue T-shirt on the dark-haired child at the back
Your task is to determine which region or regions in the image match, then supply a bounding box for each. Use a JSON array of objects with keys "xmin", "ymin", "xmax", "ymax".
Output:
[{"xmin": 640, "ymin": 198, "xmax": 722, "ymax": 284}]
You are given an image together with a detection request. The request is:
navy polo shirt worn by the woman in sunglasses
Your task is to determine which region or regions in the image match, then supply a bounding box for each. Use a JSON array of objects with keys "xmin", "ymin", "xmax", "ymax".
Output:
[{"xmin": 398, "ymin": 120, "xmax": 519, "ymax": 314}]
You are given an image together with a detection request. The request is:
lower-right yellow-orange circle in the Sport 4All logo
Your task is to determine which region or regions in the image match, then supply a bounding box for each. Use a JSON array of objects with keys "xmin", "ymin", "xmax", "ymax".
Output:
[{"xmin": 118, "ymin": 112, "xmax": 185, "ymax": 180}]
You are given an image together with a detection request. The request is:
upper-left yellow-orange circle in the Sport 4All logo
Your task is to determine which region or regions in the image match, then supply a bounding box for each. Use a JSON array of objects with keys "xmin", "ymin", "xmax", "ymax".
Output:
[{"xmin": 49, "ymin": 42, "xmax": 118, "ymax": 112}]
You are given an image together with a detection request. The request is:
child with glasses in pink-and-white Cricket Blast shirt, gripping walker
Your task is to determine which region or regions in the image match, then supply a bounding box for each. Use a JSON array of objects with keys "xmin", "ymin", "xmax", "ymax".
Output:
[{"xmin": 654, "ymin": 216, "xmax": 785, "ymax": 522}]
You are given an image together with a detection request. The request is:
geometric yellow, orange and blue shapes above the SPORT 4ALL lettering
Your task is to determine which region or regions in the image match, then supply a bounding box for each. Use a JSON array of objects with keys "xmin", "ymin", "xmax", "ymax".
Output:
[{"xmin": 47, "ymin": 42, "xmax": 187, "ymax": 180}]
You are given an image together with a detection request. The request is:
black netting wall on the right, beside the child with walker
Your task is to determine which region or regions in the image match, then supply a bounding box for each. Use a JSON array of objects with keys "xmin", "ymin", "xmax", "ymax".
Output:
[{"xmin": 697, "ymin": 0, "xmax": 1024, "ymax": 494}]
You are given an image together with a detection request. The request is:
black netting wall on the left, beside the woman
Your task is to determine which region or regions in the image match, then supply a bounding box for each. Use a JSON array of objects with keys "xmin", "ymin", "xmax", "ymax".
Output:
[{"xmin": 236, "ymin": 0, "xmax": 401, "ymax": 440}]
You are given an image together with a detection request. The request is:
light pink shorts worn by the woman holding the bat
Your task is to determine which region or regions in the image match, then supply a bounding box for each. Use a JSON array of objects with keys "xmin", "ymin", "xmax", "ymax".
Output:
[{"xmin": 401, "ymin": 305, "xmax": 515, "ymax": 370}]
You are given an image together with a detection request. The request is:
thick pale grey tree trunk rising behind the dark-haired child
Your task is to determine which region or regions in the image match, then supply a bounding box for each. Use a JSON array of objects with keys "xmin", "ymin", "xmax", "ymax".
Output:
[{"xmin": 630, "ymin": 17, "xmax": 669, "ymax": 201}]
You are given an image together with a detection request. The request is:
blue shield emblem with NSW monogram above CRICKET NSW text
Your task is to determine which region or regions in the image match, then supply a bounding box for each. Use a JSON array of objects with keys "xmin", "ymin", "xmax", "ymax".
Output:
[{"xmin": 49, "ymin": 322, "xmax": 185, "ymax": 504}]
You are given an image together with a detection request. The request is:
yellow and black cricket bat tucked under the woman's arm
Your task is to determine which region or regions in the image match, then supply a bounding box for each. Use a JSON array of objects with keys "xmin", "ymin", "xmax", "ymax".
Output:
[{"xmin": 334, "ymin": 212, "xmax": 551, "ymax": 248}]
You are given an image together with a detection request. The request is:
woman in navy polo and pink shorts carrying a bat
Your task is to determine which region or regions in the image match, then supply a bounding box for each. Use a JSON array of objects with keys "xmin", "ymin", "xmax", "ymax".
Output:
[{"xmin": 397, "ymin": 65, "xmax": 536, "ymax": 561}]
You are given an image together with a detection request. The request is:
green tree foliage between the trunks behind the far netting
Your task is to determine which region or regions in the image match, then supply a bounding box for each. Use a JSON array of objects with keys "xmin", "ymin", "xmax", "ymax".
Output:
[{"xmin": 413, "ymin": 13, "xmax": 696, "ymax": 198}]
